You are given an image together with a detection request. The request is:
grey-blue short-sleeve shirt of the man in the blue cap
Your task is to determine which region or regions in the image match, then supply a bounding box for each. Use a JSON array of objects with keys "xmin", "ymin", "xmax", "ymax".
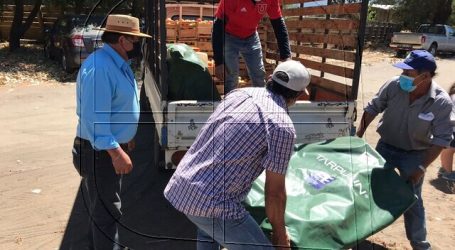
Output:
[{"xmin": 365, "ymin": 77, "xmax": 453, "ymax": 151}]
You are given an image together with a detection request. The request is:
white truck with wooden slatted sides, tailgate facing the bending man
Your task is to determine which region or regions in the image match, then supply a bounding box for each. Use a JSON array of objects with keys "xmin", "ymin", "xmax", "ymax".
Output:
[{"xmin": 141, "ymin": 1, "xmax": 368, "ymax": 169}]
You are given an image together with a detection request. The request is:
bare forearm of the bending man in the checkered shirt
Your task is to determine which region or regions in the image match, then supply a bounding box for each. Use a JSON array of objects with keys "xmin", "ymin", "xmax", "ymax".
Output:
[{"xmin": 265, "ymin": 171, "xmax": 290, "ymax": 247}]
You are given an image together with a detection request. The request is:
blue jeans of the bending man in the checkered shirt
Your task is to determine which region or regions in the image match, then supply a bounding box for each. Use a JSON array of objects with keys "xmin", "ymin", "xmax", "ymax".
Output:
[{"xmin": 186, "ymin": 214, "xmax": 273, "ymax": 250}]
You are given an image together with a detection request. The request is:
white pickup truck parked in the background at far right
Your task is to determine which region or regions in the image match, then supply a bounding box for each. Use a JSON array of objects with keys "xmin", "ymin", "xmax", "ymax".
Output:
[{"xmin": 390, "ymin": 24, "xmax": 455, "ymax": 55}]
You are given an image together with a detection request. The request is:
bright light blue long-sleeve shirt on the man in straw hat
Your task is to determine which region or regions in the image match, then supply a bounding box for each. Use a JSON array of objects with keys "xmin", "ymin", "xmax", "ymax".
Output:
[{"xmin": 76, "ymin": 44, "xmax": 139, "ymax": 150}]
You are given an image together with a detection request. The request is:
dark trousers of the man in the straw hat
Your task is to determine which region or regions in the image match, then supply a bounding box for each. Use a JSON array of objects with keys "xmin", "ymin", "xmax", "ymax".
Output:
[{"xmin": 72, "ymin": 137, "xmax": 122, "ymax": 250}]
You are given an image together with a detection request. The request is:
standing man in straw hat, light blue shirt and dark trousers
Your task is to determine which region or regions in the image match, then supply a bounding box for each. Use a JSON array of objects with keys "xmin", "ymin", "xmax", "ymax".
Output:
[{"xmin": 73, "ymin": 15, "xmax": 150, "ymax": 249}]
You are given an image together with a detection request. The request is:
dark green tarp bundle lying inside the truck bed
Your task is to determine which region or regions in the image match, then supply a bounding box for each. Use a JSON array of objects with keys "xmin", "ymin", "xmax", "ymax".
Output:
[{"xmin": 167, "ymin": 43, "xmax": 221, "ymax": 101}]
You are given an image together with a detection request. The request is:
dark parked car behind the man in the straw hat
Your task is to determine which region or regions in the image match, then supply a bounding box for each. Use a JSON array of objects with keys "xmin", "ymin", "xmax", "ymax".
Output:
[{"xmin": 44, "ymin": 15, "xmax": 105, "ymax": 73}]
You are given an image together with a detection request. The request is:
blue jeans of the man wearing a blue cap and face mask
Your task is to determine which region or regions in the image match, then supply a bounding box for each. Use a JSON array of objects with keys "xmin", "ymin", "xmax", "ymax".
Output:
[{"xmin": 376, "ymin": 140, "xmax": 431, "ymax": 250}]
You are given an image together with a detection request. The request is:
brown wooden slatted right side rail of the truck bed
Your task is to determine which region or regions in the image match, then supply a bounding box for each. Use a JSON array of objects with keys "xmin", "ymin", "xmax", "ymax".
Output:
[{"xmin": 263, "ymin": 0, "xmax": 362, "ymax": 100}]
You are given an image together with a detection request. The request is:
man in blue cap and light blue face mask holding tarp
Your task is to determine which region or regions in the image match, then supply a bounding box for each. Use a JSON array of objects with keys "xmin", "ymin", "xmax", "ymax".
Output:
[{"xmin": 357, "ymin": 50, "xmax": 452, "ymax": 250}]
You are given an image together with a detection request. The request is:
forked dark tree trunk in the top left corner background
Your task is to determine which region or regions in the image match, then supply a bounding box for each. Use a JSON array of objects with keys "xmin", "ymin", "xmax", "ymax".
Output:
[{"xmin": 8, "ymin": 0, "xmax": 43, "ymax": 52}]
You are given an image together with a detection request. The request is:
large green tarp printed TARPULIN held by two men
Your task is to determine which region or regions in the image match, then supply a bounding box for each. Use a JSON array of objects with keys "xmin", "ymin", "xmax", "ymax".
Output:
[{"xmin": 245, "ymin": 137, "xmax": 416, "ymax": 249}]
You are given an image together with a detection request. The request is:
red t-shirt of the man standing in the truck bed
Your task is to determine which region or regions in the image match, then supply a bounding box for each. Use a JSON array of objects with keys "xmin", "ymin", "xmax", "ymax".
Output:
[{"xmin": 215, "ymin": 0, "xmax": 281, "ymax": 38}]
